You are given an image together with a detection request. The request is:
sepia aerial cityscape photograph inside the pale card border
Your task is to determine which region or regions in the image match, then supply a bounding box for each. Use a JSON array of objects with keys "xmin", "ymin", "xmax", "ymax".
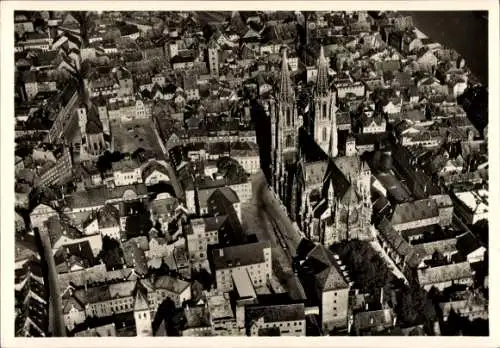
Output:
[{"xmin": 10, "ymin": 8, "xmax": 488, "ymax": 337}]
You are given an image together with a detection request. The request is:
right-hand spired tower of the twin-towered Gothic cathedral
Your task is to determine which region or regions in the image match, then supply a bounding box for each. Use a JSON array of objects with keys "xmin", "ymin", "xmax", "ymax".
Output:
[{"xmin": 313, "ymin": 47, "xmax": 338, "ymax": 157}]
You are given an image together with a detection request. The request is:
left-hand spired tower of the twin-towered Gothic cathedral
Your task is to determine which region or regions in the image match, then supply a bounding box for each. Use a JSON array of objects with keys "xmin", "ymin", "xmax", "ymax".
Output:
[{"xmin": 271, "ymin": 49, "xmax": 302, "ymax": 199}]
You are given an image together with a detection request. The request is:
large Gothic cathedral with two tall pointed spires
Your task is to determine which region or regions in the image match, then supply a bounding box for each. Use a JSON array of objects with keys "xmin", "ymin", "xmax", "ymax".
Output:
[{"xmin": 265, "ymin": 47, "xmax": 372, "ymax": 245}]
